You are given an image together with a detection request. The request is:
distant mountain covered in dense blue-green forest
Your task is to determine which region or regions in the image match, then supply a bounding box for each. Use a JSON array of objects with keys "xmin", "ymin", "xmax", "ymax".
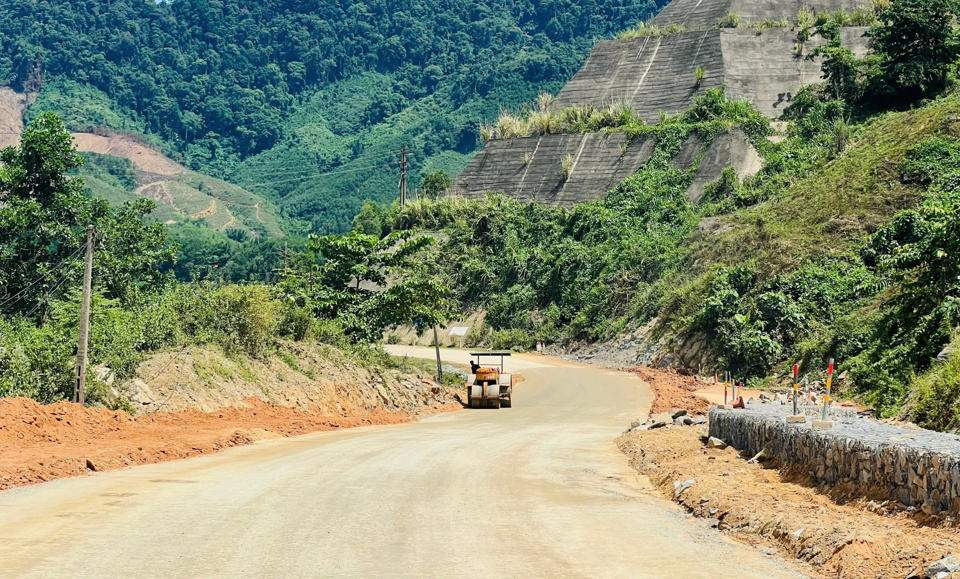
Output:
[{"xmin": 0, "ymin": 0, "xmax": 665, "ymax": 232}]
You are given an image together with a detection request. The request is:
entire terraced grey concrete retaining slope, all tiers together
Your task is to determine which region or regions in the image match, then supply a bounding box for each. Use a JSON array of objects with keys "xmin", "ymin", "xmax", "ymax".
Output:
[{"xmin": 453, "ymin": 0, "xmax": 867, "ymax": 206}]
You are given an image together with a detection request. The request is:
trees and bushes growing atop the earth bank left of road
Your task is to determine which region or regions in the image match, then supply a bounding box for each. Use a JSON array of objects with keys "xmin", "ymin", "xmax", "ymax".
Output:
[{"xmin": 0, "ymin": 113, "xmax": 447, "ymax": 405}]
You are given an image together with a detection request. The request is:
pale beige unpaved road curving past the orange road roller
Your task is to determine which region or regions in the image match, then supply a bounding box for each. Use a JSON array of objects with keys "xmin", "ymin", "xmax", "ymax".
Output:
[{"xmin": 0, "ymin": 350, "xmax": 797, "ymax": 579}]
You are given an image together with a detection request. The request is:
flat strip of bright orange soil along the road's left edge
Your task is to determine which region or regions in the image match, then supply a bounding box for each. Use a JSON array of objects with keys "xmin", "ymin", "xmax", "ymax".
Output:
[{"xmin": 0, "ymin": 397, "xmax": 462, "ymax": 490}]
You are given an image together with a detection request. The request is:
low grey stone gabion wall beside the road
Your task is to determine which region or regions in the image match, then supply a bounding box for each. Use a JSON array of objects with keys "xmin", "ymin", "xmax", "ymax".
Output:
[{"xmin": 710, "ymin": 405, "xmax": 960, "ymax": 514}]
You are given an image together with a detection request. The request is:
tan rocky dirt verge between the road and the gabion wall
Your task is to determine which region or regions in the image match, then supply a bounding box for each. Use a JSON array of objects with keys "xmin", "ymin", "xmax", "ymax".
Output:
[{"xmin": 617, "ymin": 427, "xmax": 960, "ymax": 578}]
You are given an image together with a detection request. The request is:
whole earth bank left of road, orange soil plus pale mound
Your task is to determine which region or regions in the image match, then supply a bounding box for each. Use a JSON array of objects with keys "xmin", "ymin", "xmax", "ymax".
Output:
[{"xmin": 0, "ymin": 344, "xmax": 463, "ymax": 490}]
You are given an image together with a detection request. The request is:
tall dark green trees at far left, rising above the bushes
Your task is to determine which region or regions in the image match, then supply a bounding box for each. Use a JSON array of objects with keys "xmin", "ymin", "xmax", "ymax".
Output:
[{"xmin": 0, "ymin": 113, "xmax": 173, "ymax": 314}]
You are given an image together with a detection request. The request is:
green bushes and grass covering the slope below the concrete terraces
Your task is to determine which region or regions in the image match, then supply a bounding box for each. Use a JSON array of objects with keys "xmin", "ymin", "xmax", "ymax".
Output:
[{"xmin": 344, "ymin": 0, "xmax": 960, "ymax": 428}]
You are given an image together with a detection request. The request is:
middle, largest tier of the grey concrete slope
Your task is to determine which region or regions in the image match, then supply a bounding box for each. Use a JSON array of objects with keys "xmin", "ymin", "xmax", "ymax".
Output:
[{"xmin": 554, "ymin": 28, "xmax": 867, "ymax": 123}]
